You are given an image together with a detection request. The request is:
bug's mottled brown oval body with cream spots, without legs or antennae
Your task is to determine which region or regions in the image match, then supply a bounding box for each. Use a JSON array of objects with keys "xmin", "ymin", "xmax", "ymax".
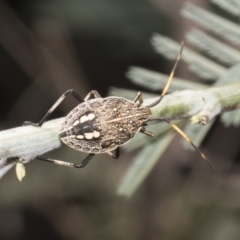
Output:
[{"xmin": 60, "ymin": 97, "xmax": 151, "ymax": 154}]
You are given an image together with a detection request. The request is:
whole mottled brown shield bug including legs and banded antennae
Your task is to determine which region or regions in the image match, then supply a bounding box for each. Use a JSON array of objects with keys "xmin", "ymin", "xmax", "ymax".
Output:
[{"xmin": 24, "ymin": 43, "xmax": 213, "ymax": 171}]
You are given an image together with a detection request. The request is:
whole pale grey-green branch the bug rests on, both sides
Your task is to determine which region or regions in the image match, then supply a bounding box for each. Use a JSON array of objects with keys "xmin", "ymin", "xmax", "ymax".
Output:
[{"xmin": 0, "ymin": 82, "xmax": 240, "ymax": 177}]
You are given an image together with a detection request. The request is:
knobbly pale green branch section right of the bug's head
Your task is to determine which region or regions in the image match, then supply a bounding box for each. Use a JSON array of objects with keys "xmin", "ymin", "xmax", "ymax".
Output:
[{"xmin": 146, "ymin": 82, "xmax": 240, "ymax": 124}]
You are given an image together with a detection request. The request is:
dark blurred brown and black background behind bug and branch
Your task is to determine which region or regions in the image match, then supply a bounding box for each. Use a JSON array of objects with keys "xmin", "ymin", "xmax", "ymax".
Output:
[{"xmin": 0, "ymin": 0, "xmax": 240, "ymax": 240}]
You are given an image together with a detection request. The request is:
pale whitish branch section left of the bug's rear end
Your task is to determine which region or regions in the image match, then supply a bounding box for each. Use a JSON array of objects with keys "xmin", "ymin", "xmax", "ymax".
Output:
[{"xmin": 0, "ymin": 118, "xmax": 64, "ymax": 178}]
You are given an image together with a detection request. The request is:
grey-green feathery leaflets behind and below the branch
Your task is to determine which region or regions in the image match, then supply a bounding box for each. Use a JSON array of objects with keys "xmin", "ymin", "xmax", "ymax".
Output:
[{"xmin": 113, "ymin": 0, "xmax": 240, "ymax": 197}]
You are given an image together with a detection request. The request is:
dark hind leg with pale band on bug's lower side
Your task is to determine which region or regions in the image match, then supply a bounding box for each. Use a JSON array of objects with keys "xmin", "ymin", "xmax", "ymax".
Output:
[{"xmin": 23, "ymin": 154, "xmax": 95, "ymax": 168}]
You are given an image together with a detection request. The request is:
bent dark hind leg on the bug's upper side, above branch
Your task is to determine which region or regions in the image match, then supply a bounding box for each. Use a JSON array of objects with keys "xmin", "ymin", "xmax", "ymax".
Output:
[{"xmin": 23, "ymin": 89, "xmax": 84, "ymax": 127}]
